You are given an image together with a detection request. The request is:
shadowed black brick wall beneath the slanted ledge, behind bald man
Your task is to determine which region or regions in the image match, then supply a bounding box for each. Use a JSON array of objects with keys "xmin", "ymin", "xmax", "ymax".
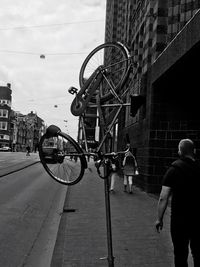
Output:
[{"xmin": 147, "ymin": 39, "xmax": 200, "ymax": 191}]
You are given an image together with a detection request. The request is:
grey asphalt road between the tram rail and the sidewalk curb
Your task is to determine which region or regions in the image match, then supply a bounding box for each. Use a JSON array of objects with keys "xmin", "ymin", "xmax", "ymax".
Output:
[{"xmin": 0, "ymin": 162, "xmax": 67, "ymax": 267}]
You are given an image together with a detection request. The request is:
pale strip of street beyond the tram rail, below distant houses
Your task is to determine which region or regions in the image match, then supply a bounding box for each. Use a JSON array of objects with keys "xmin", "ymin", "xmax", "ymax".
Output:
[{"xmin": 0, "ymin": 152, "xmax": 40, "ymax": 177}]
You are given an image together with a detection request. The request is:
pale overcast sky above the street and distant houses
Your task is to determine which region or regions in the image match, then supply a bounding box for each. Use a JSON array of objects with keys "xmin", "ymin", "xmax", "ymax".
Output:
[{"xmin": 0, "ymin": 0, "xmax": 106, "ymax": 139}]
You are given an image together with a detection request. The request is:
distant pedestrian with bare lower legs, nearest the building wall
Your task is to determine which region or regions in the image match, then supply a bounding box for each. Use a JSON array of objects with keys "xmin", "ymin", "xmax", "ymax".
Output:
[{"xmin": 122, "ymin": 144, "xmax": 137, "ymax": 194}]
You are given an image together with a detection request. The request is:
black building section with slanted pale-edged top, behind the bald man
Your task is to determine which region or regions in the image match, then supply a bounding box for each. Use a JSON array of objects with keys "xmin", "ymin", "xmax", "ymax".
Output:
[{"xmin": 147, "ymin": 13, "xmax": 200, "ymax": 193}]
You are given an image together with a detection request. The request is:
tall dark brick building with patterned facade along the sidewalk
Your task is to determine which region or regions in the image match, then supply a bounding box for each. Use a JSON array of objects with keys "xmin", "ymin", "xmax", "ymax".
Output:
[{"xmin": 105, "ymin": 0, "xmax": 200, "ymax": 192}]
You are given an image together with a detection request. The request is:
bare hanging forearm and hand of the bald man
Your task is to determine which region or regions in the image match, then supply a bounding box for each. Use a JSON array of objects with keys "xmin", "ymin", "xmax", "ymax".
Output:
[{"xmin": 155, "ymin": 186, "xmax": 171, "ymax": 233}]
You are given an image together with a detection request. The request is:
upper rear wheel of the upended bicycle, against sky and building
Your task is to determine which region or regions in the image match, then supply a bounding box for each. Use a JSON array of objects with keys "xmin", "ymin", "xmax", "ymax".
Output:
[{"xmin": 79, "ymin": 42, "xmax": 129, "ymax": 103}]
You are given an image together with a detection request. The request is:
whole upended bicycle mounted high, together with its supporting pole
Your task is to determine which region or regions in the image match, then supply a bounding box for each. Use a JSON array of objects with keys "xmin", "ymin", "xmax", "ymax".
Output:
[{"xmin": 39, "ymin": 43, "xmax": 145, "ymax": 267}]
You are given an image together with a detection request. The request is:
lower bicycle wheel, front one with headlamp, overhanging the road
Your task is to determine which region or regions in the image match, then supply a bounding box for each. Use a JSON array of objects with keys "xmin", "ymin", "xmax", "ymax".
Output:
[{"xmin": 39, "ymin": 132, "xmax": 87, "ymax": 185}]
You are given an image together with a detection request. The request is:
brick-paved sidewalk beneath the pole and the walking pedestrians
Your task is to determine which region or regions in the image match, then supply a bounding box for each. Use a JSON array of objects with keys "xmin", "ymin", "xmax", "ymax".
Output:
[{"xmin": 51, "ymin": 163, "xmax": 192, "ymax": 267}]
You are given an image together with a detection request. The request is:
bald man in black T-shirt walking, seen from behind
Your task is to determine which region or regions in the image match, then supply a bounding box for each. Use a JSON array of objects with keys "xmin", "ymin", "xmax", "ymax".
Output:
[{"xmin": 155, "ymin": 139, "xmax": 200, "ymax": 267}]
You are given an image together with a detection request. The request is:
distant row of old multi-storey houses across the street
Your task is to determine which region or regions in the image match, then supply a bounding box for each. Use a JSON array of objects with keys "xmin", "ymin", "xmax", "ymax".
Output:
[{"xmin": 0, "ymin": 83, "xmax": 45, "ymax": 151}]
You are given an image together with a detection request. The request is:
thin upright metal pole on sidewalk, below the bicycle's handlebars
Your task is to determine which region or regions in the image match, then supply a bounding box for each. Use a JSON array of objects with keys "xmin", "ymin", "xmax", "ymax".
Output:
[{"xmin": 104, "ymin": 163, "xmax": 114, "ymax": 267}]
